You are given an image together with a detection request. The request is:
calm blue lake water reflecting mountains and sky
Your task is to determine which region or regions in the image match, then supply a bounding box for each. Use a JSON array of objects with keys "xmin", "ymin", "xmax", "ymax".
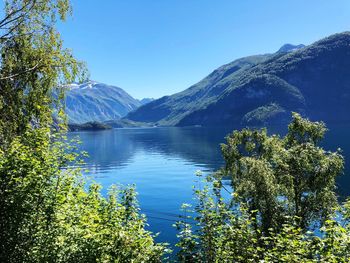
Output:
[{"xmin": 70, "ymin": 126, "xmax": 350, "ymax": 244}]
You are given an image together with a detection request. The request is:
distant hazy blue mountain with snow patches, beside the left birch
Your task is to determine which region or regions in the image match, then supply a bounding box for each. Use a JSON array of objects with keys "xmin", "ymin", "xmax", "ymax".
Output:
[{"xmin": 66, "ymin": 81, "xmax": 141, "ymax": 123}]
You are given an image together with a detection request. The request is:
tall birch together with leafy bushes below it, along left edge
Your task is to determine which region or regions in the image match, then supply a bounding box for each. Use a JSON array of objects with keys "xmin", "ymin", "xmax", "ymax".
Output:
[{"xmin": 0, "ymin": 0, "xmax": 165, "ymax": 263}]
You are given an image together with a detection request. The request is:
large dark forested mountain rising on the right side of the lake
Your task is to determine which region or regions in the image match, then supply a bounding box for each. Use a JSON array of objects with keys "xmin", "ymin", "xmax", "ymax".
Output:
[{"xmin": 126, "ymin": 32, "xmax": 350, "ymax": 126}]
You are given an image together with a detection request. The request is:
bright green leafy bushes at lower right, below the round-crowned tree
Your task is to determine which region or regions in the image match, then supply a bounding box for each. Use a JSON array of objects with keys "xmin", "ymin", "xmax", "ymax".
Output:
[{"xmin": 177, "ymin": 177, "xmax": 350, "ymax": 263}]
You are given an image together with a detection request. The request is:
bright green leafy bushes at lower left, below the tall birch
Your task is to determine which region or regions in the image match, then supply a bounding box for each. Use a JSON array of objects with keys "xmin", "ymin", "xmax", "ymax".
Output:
[{"xmin": 0, "ymin": 129, "xmax": 164, "ymax": 262}]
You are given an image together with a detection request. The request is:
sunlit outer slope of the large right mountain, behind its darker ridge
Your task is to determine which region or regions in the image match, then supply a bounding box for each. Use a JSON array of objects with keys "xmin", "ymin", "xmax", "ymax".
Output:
[{"xmin": 127, "ymin": 55, "xmax": 270, "ymax": 125}]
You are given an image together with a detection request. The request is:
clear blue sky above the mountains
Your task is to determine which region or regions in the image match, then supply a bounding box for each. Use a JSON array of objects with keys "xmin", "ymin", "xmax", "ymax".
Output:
[{"xmin": 59, "ymin": 0, "xmax": 350, "ymax": 98}]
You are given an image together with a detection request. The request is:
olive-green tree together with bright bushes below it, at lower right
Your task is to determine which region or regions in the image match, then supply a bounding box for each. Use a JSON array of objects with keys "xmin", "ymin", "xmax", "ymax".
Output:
[{"xmin": 176, "ymin": 114, "xmax": 350, "ymax": 263}]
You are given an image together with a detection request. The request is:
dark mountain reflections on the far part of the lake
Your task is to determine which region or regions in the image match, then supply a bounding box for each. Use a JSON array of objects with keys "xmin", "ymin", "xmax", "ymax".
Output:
[{"xmin": 71, "ymin": 124, "xmax": 350, "ymax": 196}]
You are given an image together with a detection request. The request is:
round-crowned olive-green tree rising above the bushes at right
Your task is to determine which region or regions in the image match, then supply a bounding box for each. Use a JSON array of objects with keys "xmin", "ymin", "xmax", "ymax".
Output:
[{"xmin": 222, "ymin": 113, "xmax": 344, "ymax": 234}]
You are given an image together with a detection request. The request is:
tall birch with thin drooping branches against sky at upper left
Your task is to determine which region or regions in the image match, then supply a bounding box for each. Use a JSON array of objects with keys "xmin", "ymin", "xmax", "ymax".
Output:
[{"xmin": 0, "ymin": 0, "xmax": 85, "ymax": 147}]
